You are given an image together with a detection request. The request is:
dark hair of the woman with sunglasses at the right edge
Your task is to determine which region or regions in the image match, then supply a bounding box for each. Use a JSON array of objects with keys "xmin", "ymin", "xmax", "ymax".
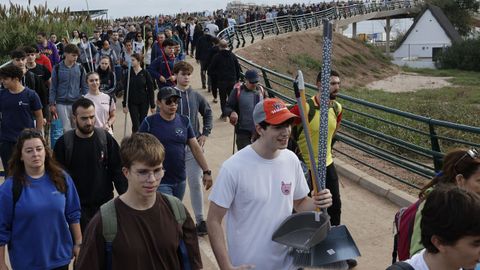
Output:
[{"xmin": 419, "ymin": 148, "xmax": 480, "ymax": 198}]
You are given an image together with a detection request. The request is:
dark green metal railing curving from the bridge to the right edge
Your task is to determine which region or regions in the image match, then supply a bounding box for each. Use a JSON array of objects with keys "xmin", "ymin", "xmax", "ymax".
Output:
[{"xmin": 219, "ymin": 1, "xmax": 480, "ymax": 189}]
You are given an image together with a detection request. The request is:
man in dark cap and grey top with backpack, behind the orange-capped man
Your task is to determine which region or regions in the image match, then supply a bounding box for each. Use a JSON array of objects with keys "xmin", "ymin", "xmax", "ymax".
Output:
[{"xmin": 224, "ymin": 69, "xmax": 266, "ymax": 150}]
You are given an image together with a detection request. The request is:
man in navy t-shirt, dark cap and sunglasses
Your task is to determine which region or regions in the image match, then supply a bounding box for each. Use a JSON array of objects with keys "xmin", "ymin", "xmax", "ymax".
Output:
[{"xmin": 138, "ymin": 87, "xmax": 212, "ymax": 200}]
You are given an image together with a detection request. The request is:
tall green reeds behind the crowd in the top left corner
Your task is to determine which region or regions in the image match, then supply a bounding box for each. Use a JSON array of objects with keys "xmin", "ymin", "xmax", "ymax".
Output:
[{"xmin": 0, "ymin": 3, "xmax": 104, "ymax": 64}]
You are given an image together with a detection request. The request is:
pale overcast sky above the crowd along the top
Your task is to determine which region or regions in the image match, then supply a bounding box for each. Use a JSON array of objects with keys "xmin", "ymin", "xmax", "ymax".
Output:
[{"xmin": 4, "ymin": 0, "xmax": 323, "ymax": 18}]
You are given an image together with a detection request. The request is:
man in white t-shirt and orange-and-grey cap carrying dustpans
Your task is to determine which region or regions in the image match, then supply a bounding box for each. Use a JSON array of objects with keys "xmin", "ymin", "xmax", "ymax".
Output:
[{"xmin": 207, "ymin": 98, "xmax": 332, "ymax": 270}]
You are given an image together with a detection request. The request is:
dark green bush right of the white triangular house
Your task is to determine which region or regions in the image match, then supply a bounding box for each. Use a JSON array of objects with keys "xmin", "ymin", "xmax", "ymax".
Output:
[{"xmin": 437, "ymin": 38, "xmax": 480, "ymax": 71}]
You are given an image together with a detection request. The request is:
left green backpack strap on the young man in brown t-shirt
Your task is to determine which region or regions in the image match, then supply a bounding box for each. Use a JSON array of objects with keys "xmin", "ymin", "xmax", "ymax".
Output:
[{"xmin": 100, "ymin": 198, "xmax": 117, "ymax": 270}]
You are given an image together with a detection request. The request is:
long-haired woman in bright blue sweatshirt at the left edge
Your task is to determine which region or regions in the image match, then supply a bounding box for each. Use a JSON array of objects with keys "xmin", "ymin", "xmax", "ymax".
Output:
[{"xmin": 0, "ymin": 129, "xmax": 82, "ymax": 270}]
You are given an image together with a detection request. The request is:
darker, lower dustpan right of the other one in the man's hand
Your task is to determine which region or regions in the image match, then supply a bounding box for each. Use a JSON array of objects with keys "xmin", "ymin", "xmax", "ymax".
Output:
[{"xmin": 294, "ymin": 225, "xmax": 360, "ymax": 266}]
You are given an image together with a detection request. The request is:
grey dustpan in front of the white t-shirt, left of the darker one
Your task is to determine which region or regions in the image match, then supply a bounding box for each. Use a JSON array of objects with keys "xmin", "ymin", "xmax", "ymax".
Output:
[{"xmin": 272, "ymin": 211, "xmax": 330, "ymax": 250}]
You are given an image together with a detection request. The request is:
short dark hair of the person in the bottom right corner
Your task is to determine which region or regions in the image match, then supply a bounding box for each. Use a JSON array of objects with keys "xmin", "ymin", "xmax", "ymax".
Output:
[{"xmin": 420, "ymin": 185, "xmax": 480, "ymax": 253}]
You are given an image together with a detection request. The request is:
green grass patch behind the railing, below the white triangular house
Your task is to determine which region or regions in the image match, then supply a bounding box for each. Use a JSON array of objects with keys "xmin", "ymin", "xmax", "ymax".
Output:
[{"xmin": 340, "ymin": 69, "xmax": 480, "ymax": 153}]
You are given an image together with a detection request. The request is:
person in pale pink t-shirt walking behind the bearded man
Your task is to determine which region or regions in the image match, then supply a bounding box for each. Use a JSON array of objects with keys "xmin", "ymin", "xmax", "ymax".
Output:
[{"xmin": 85, "ymin": 72, "xmax": 116, "ymax": 135}]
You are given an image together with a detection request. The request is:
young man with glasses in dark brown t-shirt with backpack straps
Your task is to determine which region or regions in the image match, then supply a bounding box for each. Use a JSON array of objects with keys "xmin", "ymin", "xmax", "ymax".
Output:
[{"xmin": 75, "ymin": 133, "xmax": 202, "ymax": 270}]
